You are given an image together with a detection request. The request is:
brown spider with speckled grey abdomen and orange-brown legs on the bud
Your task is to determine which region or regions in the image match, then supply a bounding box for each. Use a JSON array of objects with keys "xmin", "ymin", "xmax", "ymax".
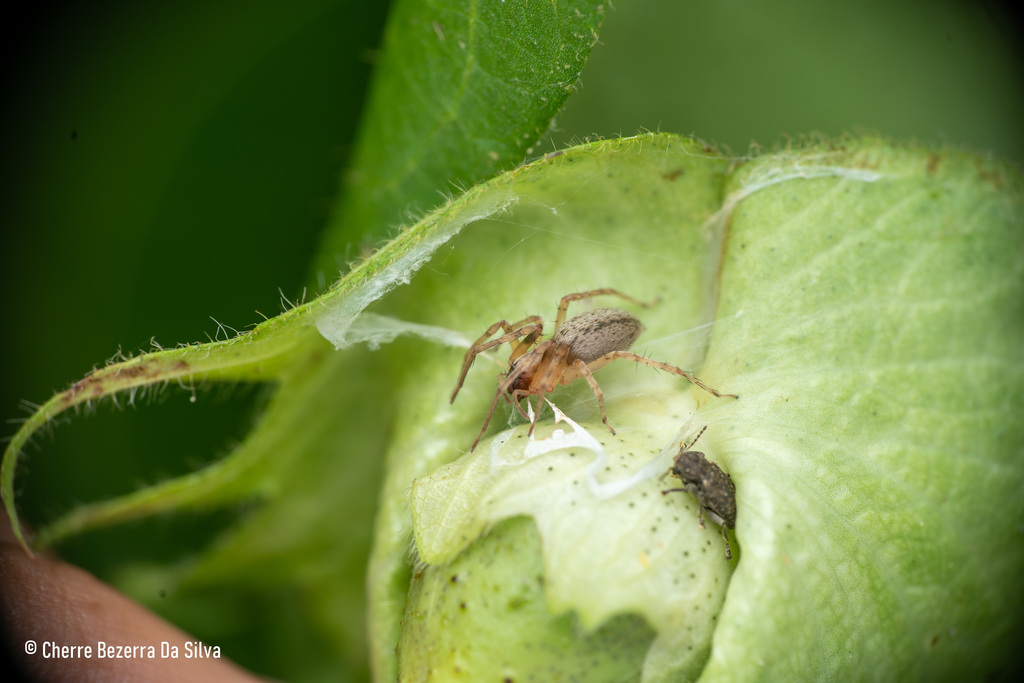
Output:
[{"xmin": 452, "ymin": 288, "xmax": 737, "ymax": 451}]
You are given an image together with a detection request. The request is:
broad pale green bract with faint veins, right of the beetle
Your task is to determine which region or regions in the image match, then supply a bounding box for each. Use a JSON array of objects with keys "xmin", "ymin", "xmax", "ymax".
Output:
[{"xmin": 706, "ymin": 144, "xmax": 1024, "ymax": 680}]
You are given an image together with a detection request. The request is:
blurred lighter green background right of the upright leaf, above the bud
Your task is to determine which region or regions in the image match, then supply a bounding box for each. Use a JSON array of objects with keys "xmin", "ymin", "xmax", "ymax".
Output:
[{"xmin": 553, "ymin": 0, "xmax": 1024, "ymax": 163}]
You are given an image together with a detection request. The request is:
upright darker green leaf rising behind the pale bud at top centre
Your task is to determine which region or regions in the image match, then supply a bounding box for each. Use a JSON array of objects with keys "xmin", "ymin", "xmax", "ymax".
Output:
[{"xmin": 317, "ymin": 0, "xmax": 604, "ymax": 272}]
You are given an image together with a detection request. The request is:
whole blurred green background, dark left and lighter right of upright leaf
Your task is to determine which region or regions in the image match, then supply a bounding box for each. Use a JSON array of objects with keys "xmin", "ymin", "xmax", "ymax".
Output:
[{"xmin": 0, "ymin": 0, "xmax": 1024, "ymax": 675}]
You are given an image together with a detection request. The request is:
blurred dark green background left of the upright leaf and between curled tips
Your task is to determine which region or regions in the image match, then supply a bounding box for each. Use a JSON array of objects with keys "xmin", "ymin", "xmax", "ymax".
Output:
[{"xmin": 0, "ymin": 0, "xmax": 387, "ymax": 574}]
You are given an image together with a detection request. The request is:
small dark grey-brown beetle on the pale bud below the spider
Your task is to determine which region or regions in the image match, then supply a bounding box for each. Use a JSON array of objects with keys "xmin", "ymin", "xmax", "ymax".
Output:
[{"xmin": 662, "ymin": 427, "xmax": 736, "ymax": 560}]
